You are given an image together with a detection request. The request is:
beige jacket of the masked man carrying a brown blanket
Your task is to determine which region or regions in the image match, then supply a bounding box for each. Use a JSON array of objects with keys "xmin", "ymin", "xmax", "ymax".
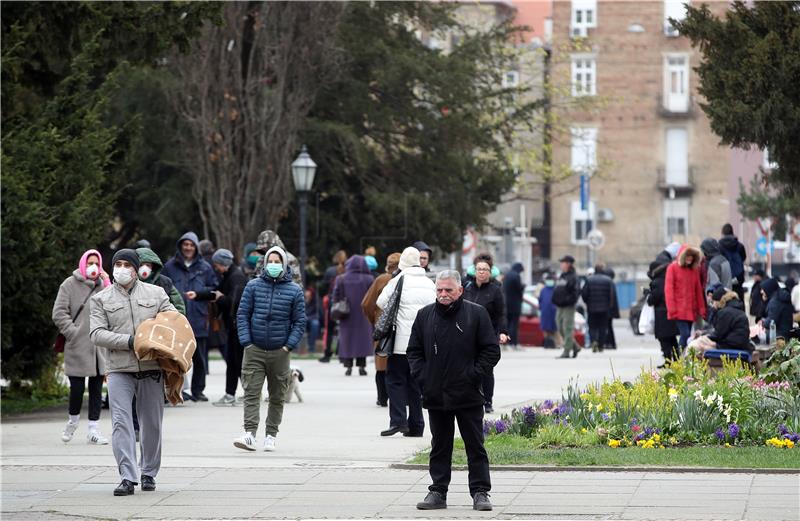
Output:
[{"xmin": 89, "ymin": 280, "xmax": 177, "ymax": 373}]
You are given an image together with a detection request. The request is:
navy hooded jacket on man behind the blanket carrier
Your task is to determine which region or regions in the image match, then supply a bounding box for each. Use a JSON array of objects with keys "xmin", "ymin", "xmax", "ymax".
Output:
[{"xmin": 162, "ymin": 232, "xmax": 218, "ymax": 338}]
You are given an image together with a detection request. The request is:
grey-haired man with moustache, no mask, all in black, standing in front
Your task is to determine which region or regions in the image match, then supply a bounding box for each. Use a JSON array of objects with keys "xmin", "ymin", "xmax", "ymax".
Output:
[{"xmin": 406, "ymin": 270, "xmax": 500, "ymax": 510}]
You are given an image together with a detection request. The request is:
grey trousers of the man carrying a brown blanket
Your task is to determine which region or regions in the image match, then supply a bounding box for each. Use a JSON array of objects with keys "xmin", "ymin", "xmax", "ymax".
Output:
[{"xmin": 108, "ymin": 373, "xmax": 164, "ymax": 483}]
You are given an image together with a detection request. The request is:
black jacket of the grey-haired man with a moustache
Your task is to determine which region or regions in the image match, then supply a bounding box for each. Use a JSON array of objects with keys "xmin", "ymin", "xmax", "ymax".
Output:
[{"xmin": 406, "ymin": 298, "xmax": 500, "ymax": 410}]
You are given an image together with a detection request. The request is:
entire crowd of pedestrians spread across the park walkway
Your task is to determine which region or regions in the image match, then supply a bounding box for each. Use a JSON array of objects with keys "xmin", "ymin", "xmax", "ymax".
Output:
[{"xmin": 53, "ymin": 221, "xmax": 800, "ymax": 502}]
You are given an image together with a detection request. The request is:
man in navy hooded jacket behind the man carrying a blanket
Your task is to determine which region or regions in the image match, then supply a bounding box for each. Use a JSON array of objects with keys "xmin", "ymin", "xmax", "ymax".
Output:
[{"xmin": 163, "ymin": 232, "xmax": 217, "ymax": 402}]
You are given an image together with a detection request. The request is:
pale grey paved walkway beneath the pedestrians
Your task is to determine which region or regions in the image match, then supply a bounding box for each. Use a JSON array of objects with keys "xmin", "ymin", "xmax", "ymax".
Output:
[{"xmin": 0, "ymin": 322, "xmax": 800, "ymax": 520}]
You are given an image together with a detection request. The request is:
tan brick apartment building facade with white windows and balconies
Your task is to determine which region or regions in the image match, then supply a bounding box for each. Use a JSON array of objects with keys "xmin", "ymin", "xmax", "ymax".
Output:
[{"xmin": 551, "ymin": 0, "xmax": 738, "ymax": 281}]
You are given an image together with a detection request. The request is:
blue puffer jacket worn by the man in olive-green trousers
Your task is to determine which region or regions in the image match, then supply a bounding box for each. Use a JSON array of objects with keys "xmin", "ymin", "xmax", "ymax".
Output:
[{"xmin": 236, "ymin": 248, "xmax": 306, "ymax": 351}]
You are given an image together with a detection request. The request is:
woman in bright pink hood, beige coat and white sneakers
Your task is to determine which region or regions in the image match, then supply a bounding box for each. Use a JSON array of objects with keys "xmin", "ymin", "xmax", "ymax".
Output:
[{"xmin": 53, "ymin": 250, "xmax": 111, "ymax": 445}]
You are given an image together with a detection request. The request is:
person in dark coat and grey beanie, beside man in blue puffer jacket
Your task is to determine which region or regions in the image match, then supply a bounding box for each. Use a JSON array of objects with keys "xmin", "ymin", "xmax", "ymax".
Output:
[{"xmin": 211, "ymin": 248, "xmax": 247, "ymax": 406}]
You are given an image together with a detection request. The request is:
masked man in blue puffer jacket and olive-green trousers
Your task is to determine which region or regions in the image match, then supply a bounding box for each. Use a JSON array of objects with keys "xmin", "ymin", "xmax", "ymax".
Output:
[{"xmin": 233, "ymin": 246, "xmax": 306, "ymax": 451}]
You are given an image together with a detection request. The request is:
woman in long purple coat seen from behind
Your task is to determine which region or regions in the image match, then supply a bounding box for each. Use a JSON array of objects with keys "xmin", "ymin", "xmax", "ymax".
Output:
[{"xmin": 333, "ymin": 255, "xmax": 374, "ymax": 376}]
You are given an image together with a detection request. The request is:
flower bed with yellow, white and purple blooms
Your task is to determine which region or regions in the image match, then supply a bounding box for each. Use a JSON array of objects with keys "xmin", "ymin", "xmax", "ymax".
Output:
[{"xmin": 484, "ymin": 350, "xmax": 800, "ymax": 449}]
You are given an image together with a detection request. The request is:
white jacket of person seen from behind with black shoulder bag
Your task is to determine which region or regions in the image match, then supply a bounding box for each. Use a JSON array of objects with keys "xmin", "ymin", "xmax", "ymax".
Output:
[{"xmin": 378, "ymin": 266, "xmax": 436, "ymax": 355}]
